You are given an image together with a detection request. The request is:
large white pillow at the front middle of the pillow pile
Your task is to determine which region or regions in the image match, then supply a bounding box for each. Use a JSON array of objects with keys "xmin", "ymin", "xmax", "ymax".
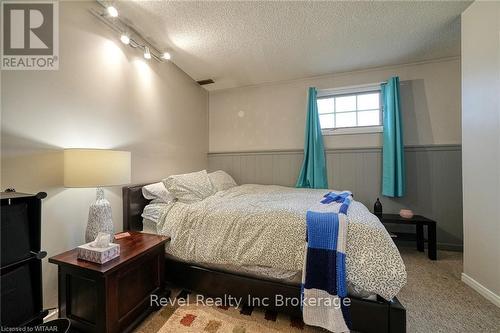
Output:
[{"xmin": 163, "ymin": 170, "xmax": 215, "ymax": 203}]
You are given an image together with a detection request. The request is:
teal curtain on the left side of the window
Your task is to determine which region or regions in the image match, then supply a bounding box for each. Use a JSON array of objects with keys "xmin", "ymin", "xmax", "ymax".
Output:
[{"xmin": 295, "ymin": 87, "xmax": 328, "ymax": 188}]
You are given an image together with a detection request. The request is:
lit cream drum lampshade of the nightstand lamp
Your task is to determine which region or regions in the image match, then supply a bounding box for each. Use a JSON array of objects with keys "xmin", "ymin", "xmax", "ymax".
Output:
[{"xmin": 64, "ymin": 149, "xmax": 130, "ymax": 187}]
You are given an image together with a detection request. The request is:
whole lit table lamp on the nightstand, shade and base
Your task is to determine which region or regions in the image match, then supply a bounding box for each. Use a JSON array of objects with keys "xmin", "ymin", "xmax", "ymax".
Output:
[{"xmin": 64, "ymin": 149, "xmax": 130, "ymax": 243}]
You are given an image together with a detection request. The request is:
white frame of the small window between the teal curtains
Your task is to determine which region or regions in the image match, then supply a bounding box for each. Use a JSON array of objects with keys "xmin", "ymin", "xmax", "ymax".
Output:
[{"xmin": 316, "ymin": 82, "xmax": 384, "ymax": 135}]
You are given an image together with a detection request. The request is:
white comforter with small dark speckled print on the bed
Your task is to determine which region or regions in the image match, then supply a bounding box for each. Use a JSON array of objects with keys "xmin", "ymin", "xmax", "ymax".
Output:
[{"xmin": 157, "ymin": 184, "xmax": 406, "ymax": 299}]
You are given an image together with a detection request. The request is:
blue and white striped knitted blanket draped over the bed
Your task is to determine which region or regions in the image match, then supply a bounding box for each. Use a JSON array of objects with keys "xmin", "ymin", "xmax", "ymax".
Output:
[{"xmin": 302, "ymin": 192, "xmax": 352, "ymax": 332}]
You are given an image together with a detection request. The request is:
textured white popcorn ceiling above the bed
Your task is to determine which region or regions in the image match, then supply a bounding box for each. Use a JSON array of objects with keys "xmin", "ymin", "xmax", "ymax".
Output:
[{"xmin": 116, "ymin": 1, "xmax": 470, "ymax": 90}]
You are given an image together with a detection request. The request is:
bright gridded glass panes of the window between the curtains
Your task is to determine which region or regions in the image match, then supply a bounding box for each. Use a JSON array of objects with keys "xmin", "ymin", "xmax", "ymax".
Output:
[{"xmin": 317, "ymin": 87, "xmax": 382, "ymax": 133}]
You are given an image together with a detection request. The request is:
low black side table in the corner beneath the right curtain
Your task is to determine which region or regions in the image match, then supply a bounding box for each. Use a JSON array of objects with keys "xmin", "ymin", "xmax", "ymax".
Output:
[{"xmin": 378, "ymin": 214, "xmax": 437, "ymax": 260}]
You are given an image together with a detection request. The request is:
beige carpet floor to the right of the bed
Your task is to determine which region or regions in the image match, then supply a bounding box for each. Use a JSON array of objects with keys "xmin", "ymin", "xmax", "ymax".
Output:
[{"xmin": 398, "ymin": 248, "xmax": 500, "ymax": 333}]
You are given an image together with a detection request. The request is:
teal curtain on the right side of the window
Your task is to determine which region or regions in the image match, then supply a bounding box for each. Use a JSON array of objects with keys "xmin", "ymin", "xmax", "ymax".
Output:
[{"xmin": 381, "ymin": 77, "xmax": 406, "ymax": 197}]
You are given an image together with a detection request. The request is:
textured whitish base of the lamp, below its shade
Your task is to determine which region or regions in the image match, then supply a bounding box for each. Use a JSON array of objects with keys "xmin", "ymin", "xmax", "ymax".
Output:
[{"xmin": 85, "ymin": 187, "xmax": 114, "ymax": 243}]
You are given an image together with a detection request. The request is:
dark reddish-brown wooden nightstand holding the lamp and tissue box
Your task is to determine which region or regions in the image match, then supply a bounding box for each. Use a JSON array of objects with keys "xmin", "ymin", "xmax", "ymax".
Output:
[{"xmin": 49, "ymin": 232, "xmax": 169, "ymax": 332}]
